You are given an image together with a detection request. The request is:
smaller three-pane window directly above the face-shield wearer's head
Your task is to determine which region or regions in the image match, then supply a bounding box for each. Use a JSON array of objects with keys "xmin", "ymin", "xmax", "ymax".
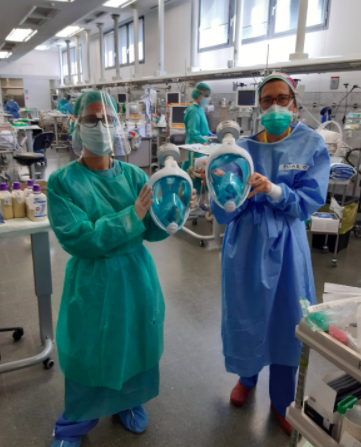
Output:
[{"xmin": 104, "ymin": 18, "xmax": 144, "ymax": 68}]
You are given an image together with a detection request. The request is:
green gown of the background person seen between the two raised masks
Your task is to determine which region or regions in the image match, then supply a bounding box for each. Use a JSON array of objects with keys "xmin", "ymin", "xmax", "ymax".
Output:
[{"xmin": 182, "ymin": 103, "xmax": 209, "ymax": 194}]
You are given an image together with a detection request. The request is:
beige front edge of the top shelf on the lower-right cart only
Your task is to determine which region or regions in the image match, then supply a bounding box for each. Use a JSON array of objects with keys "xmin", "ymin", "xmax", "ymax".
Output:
[{"xmin": 296, "ymin": 319, "xmax": 361, "ymax": 382}]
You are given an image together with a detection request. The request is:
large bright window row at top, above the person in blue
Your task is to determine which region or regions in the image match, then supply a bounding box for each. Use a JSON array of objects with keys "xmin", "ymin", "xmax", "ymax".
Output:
[{"xmin": 199, "ymin": 0, "xmax": 331, "ymax": 51}]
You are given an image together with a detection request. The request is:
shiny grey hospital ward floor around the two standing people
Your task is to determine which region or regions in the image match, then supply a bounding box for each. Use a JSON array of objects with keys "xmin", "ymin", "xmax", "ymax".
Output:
[{"xmin": 0, "ymin": 154, "xmax": 361, "ymax": 447}]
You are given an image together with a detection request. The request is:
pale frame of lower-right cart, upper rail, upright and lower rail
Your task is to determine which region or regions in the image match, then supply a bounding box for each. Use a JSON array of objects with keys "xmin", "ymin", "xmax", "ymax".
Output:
[{"xmin": 286, "ymin": 319, "xmax": 361, "ymax": 447}]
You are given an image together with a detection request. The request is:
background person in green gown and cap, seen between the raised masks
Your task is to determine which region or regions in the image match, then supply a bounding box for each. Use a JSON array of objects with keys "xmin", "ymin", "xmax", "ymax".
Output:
[{"xmin": 182, "ymin": 82, "xmax": 211, "ymax": 195}]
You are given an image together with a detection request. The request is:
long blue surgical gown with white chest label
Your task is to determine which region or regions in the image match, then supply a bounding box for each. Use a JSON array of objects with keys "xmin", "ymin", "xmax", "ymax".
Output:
[{"xmin": 211, "ymin": 124, "xmax": 330, "ymax": 377}]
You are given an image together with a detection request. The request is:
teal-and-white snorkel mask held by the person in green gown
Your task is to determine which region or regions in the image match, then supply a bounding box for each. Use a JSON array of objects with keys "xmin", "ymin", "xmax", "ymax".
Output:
[{"xmin": 148, "ymin": 143, "xmax": 193, "ymax": 234}]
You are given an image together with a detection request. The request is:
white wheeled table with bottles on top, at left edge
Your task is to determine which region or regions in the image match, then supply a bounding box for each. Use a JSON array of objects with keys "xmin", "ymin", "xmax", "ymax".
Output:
[{"xmin": 0, "ymin": 218, "xmax": 54, "ymax": 374}]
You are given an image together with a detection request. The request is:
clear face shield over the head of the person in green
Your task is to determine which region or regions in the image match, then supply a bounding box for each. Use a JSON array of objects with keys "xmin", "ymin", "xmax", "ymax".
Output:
[{"xmin": 72, "ymin": 91, "xmax": 131, "ymax": 158}]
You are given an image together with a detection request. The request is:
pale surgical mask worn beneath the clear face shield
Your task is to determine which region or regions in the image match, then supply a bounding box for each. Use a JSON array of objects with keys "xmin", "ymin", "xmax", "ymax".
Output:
[{"xmin": 80, "ymin": 121, "xmax": 116, "ymax": 157}]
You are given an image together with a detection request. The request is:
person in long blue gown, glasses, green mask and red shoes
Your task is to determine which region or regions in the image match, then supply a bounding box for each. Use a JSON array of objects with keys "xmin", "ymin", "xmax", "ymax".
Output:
[{"xmin": 200, "ymin": 73, "xmax": 330, "ymax": 434}]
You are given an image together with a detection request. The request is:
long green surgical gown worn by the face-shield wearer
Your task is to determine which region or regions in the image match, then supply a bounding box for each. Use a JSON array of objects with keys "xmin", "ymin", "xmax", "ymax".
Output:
[{"xmin": 48, "ymin": 160, "xmax": 167, "ymax": 391}]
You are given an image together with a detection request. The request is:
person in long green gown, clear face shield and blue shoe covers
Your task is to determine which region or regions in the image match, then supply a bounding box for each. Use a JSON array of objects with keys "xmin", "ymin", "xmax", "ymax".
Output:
[{"xmin": 48, "ymin": 91, "xmax": 167, "ymax": 447}]
